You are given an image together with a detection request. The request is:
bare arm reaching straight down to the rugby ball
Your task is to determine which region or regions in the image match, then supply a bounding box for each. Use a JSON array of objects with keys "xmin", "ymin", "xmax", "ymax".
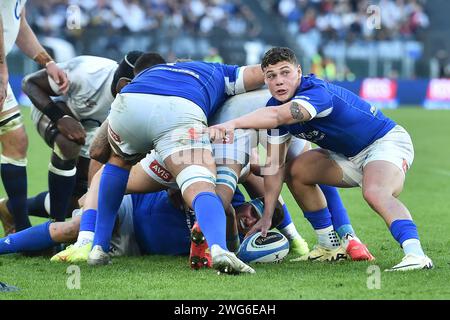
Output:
[{"xmin": 247, "ymin": 140, "xmax": 289, "ymax": 237}]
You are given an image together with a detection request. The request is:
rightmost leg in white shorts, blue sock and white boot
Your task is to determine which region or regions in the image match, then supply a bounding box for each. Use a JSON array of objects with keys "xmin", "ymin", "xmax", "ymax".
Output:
[{"xmin": 362, "ymin": 126, "xmax": 433, "ymax": 271}]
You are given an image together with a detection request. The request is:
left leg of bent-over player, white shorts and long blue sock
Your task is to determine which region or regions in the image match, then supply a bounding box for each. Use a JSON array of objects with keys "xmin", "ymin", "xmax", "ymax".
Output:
[{"xmin": 88, "ymin": 94, "xmax": 169, "ymax": 265}]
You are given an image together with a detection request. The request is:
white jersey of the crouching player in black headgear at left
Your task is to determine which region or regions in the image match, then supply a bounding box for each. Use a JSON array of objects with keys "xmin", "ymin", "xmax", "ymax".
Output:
[{"xmin": 48, "ymin": 56, "xmax": 118, "ymax": 127}]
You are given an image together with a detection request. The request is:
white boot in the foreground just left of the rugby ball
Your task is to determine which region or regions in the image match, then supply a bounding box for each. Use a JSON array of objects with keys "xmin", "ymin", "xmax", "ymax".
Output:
[{"xmin": 211, "ymin": 244, "xmax": 255, "ymax": 274}]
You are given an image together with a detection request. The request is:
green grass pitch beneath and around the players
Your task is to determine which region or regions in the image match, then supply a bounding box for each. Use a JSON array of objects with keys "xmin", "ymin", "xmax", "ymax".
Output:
[{"xmin": 0, "ymin": 108, "xmax": 450, "ymax": 300}]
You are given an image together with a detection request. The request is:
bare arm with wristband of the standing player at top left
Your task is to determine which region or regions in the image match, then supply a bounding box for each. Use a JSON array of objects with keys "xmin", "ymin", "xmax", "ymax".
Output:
[{"xmin": 16, "ymin": 8, "xmax": 69, "ymax": 93}]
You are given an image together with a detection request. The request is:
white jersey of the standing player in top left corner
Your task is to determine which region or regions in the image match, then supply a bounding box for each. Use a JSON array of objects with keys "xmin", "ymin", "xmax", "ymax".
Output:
[{"xmin": 0, "ymin": 0, "xmax": 27, "ymax": 56}]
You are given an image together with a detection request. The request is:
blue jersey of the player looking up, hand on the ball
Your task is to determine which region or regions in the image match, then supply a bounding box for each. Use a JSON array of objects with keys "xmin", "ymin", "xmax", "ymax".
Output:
[{"xmin": 267, "ymin": 74, "xmax": 396, "ymax": 157}]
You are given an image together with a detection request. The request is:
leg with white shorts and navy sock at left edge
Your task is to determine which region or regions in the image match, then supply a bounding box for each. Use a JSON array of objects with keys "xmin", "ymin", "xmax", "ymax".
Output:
[{"xmin": 0, "ymin": 95, "xmax": 31, "ymax": 231}]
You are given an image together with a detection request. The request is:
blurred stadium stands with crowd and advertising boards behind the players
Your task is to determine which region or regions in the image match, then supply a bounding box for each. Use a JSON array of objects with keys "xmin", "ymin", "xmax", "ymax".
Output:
[{"xmin": 8, "ymin": 0, "xmax": 450, "ymax": 108}]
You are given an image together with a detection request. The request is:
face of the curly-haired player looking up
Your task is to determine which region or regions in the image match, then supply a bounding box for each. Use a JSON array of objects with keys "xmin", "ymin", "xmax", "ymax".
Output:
[{"xmin": 264, "ymin": 61, "xmax": 302, "ymax": 102}]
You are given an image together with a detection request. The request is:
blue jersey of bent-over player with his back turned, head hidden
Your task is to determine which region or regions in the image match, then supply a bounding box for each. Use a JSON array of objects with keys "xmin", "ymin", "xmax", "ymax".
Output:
[{"xmin": 120, "ymin": 61, "xmax": 245, "ymax": 117}]
